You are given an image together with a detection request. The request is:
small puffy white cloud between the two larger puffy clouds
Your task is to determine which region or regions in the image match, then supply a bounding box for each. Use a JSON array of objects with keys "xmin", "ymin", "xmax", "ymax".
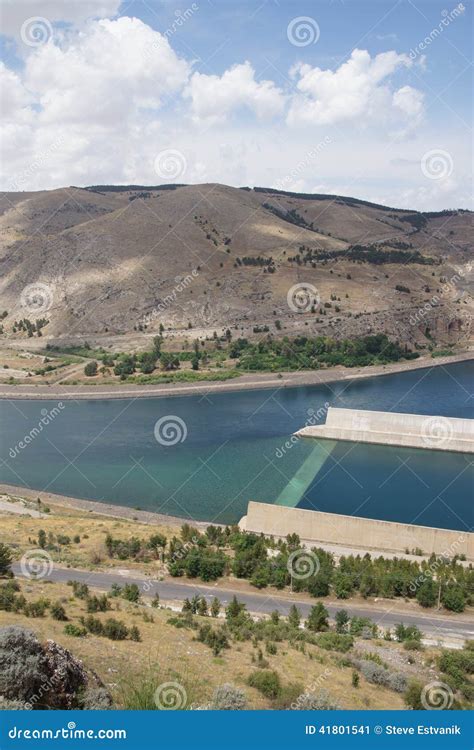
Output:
[{"xmin": 185, "ymin": 62, "xmax": 285, "ymax": 123}]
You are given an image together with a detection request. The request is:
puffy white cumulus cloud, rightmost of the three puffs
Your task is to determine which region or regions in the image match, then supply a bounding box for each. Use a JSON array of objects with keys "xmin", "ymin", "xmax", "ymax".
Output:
[{"xmin": 287, "ymin": 49, "xmax": 422, "ymax": 125}]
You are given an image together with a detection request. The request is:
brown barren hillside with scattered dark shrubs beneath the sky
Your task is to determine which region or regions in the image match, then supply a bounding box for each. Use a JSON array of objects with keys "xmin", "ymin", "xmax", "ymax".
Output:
[{"xmin": 0, "ymin": 184, "xmax": 473, "ymax": 346}]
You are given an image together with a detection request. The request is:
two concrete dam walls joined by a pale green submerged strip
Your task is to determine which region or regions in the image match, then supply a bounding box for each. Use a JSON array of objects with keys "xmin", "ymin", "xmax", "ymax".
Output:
[{"xmin": 240, "ymin": 408, "xmax": 474, "ymax": 560}]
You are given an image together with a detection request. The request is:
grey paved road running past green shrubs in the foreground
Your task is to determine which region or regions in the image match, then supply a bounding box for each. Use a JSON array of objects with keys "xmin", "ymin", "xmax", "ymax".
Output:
[{"xmin": 12, "ymin": 563, "xmax": 474, "ymax": 640}]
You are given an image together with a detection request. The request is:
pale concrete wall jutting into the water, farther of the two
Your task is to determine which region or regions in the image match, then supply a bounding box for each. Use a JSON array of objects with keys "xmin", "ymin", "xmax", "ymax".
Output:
[{"xmin": 295, "ymin": 408, "xmax": 474, "ymax": 453}]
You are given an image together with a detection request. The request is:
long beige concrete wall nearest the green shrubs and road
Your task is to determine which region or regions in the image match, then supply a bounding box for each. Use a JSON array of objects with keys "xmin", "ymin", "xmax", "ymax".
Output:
[{"xmin": 243, "ymin": 501, "xmax": 474, "ymax": 560}]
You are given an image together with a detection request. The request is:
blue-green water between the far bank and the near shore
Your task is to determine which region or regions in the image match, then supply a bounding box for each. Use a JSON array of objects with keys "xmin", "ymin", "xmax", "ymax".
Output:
[{"xmin": 0, "ymin": 363, "xmax": 474, "ymax": 529}]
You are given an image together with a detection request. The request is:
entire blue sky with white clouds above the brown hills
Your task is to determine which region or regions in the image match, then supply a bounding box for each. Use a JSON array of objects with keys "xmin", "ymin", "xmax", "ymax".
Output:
[{"xmin": 0, "ymin": 0, "xmax": 472, "ymax": 210}]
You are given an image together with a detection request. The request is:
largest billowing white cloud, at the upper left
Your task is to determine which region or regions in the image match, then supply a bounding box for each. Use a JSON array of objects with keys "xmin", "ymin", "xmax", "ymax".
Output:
[{"xmin": 24, "ymin": 18, "xmax": 189, "ymax": 128}]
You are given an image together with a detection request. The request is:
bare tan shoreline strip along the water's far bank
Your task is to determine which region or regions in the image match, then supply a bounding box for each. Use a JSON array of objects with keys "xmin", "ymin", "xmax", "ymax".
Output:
[{"xmin": 0, "ymin": 351, "xmax": 474, "ymax": 401}]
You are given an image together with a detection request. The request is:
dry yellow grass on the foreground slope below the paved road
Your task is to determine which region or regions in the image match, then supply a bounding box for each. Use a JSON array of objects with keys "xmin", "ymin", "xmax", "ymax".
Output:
[{"xmin": 0, "ymin": 581, "xmax": 404, "ymax": 709}]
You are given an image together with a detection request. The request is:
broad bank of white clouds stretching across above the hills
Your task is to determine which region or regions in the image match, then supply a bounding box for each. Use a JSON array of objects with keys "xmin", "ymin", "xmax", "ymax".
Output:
[{"xmin": 0, "ymin": 11, "xmax": 469, "ymax": 209}]
